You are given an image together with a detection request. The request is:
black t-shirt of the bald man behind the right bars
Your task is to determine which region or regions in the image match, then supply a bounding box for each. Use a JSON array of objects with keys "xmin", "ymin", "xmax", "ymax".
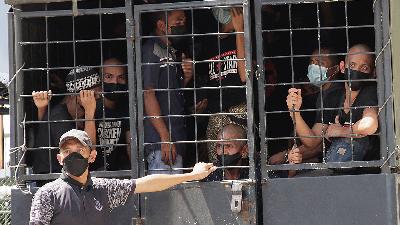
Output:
[{"xmin": 315, "ymin": 82, "xmax": 378, "ymax": 125}]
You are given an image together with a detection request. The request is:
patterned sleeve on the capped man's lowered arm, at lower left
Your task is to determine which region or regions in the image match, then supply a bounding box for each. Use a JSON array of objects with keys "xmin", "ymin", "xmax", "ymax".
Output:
[{"xmin": 29, "ymin": 188, "xmax": 54, "ymax": 225}]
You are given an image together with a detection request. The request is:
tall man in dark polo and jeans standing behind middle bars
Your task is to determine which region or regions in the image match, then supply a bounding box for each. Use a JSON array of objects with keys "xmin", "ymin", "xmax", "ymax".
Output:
[{"xmin": 140, "ymin": 10, "xmax": 192, "ymax": 172}]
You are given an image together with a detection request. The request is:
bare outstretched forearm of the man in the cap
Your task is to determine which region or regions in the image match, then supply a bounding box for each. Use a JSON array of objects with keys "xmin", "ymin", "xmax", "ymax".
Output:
[{"xmin": 135, "ymin": 173, "xmax": 196, "ymax": 193}]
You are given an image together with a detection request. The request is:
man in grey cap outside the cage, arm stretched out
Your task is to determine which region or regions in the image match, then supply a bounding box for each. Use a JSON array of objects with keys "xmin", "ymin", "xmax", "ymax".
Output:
[{"xmin": 29, "ymin": 129, "xmax": 216, "ymax": 225}]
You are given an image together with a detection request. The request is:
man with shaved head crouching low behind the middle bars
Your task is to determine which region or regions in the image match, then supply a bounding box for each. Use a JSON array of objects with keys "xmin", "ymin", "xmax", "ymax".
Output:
[{"xmin": 206, "ymin": 124, "xmax": 249, "ymax": 181}]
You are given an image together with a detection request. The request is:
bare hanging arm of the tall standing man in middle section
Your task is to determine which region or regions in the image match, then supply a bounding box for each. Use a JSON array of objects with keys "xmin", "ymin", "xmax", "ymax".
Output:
[{"xmin": 144, "ymin": 91, "xmax": 169, "ymax": 140}]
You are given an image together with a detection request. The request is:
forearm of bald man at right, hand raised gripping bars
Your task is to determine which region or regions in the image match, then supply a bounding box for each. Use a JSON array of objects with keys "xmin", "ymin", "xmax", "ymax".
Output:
[{"xmin": 292, "ymin": 112, "xmax": 322, "ymax": 149}]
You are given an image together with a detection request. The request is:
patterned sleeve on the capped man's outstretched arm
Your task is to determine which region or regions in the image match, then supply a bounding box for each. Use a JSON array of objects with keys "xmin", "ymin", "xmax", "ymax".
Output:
[{"xmin": 98, "ymin": 178, "xmax": 136, "ymax": 210}]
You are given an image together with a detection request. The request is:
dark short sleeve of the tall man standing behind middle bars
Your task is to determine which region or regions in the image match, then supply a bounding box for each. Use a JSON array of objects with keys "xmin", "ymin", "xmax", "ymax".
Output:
[{"xmin": 142, "ymin": 43, "xmax": 161, "ymax": 89}]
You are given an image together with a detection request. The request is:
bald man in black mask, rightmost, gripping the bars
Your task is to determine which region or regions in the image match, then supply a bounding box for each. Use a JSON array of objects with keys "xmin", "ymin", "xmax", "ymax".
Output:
[{"xmin": 286, "ymin": 44, "xmax": 378, "ymax": 165}]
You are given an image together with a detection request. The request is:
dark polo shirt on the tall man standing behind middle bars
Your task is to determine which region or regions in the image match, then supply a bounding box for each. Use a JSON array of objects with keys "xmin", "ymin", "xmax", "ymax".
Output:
[{"xmin": 142, "ymin": 38, "xmax": 186, "ymax": 153}]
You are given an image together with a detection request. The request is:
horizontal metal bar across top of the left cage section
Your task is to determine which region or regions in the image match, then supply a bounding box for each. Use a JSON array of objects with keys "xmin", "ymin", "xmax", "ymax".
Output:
[{"xmin": 14, "ymin": 7, "xmax": 126, "ymax": 18}]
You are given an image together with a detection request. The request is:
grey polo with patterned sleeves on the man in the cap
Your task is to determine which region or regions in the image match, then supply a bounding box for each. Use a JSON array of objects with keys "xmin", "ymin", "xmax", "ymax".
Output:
[{"xmin": 29, "ymin": 172, "xmax": 136, "ymax": 225}]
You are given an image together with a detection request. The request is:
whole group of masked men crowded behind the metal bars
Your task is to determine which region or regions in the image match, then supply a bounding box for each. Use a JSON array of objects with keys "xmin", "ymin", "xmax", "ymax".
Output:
[{"xmin": 28, "ymin": 8, "xmax": 378, "ymax": 183}]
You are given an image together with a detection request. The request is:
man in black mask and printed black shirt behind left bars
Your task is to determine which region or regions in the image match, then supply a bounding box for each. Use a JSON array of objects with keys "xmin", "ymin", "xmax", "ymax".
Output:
[{"xmin": 90, "ymin": 58, "xmax": 130, "ymax": 170}]
